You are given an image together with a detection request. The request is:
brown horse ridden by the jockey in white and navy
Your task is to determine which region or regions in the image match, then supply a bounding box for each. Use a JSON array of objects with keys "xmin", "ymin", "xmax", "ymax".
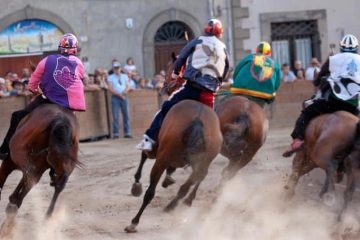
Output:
[{"xmin": 125, "ymin": 54, "xmax": 222, "ymax": 233}]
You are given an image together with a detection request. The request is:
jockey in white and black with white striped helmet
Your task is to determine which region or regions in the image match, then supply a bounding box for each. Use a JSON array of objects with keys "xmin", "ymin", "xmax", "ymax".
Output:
[{"xmin": 283, "ymin": 34, "xmax": 360, "ymax": 157}]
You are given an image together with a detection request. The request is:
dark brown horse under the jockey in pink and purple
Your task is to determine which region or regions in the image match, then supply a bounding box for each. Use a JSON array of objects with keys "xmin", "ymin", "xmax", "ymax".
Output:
[{"xmin": 0, "ymin": 104, "xmax": 81, "ymax": 235}]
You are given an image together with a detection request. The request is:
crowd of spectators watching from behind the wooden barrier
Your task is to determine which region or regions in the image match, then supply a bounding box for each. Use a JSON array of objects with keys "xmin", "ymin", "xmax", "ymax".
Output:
[{"xmin": 0, "ymin": 57, "xmax": 320, "ymax": 98}]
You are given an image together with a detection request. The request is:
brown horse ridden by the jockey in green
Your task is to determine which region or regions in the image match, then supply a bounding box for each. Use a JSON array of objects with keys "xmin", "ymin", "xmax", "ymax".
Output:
[{"xmin": 156, "ymin": 53, "xmax": 269, "ymax": 187}]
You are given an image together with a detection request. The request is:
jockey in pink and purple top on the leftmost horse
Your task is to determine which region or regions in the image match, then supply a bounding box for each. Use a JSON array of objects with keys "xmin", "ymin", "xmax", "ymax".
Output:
[{"xmin": 0, "ymin": 33, "xmax": 86, "ymax": 159}]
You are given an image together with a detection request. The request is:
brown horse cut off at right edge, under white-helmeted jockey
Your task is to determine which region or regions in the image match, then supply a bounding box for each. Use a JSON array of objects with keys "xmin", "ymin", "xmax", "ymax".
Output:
[{"xmin": 285, "ymin": 111, "xmax": 360, "ymax": 219}]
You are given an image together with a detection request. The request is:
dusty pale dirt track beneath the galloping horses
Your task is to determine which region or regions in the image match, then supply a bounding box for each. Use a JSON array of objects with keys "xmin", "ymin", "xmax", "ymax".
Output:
[{"xmin": 0, "ymin": 129, "xmax": 360, "ymax": 240}]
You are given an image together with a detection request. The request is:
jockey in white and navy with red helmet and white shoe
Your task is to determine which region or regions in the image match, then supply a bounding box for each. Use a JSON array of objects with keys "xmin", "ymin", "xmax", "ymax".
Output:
[{"xmin": 136, "ymin": 19, "xmax": 229, "ymax": 151}]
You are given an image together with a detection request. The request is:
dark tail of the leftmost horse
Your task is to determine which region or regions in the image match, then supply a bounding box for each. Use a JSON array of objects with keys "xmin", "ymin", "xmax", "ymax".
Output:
[{"xmin": 49, "ymin": 114, "xmax": 81, "ymax": 166}]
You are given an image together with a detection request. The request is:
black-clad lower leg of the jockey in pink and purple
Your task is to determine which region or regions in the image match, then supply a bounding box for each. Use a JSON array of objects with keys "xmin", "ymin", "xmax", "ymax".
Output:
[{"xmin": 0, "ymin": 111, "xmax": 28, "ymax": 160}]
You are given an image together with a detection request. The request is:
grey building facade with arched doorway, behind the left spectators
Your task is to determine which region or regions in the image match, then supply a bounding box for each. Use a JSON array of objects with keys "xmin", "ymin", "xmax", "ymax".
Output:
[{"xmin": 0, "ymin": 0, "xmax": 236, "ymax": 77}]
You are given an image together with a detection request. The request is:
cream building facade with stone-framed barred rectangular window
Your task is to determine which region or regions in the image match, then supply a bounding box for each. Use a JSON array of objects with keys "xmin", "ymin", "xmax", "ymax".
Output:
[{"xmin": 233, "ymin": 0, "xmax": 360, "ymax": 66}]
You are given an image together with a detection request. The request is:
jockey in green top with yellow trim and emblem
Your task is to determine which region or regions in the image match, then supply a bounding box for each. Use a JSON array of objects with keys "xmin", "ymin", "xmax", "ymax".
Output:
[{"xmin": 230, "ymin": 42, "xmax": 281, "ymax": 107}]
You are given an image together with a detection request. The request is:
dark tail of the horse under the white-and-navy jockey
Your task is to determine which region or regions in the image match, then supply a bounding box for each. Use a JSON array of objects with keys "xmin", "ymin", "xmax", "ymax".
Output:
[{"xmin": 182, "ymin": 118, "xmax": 205, "ymax": 154}]
